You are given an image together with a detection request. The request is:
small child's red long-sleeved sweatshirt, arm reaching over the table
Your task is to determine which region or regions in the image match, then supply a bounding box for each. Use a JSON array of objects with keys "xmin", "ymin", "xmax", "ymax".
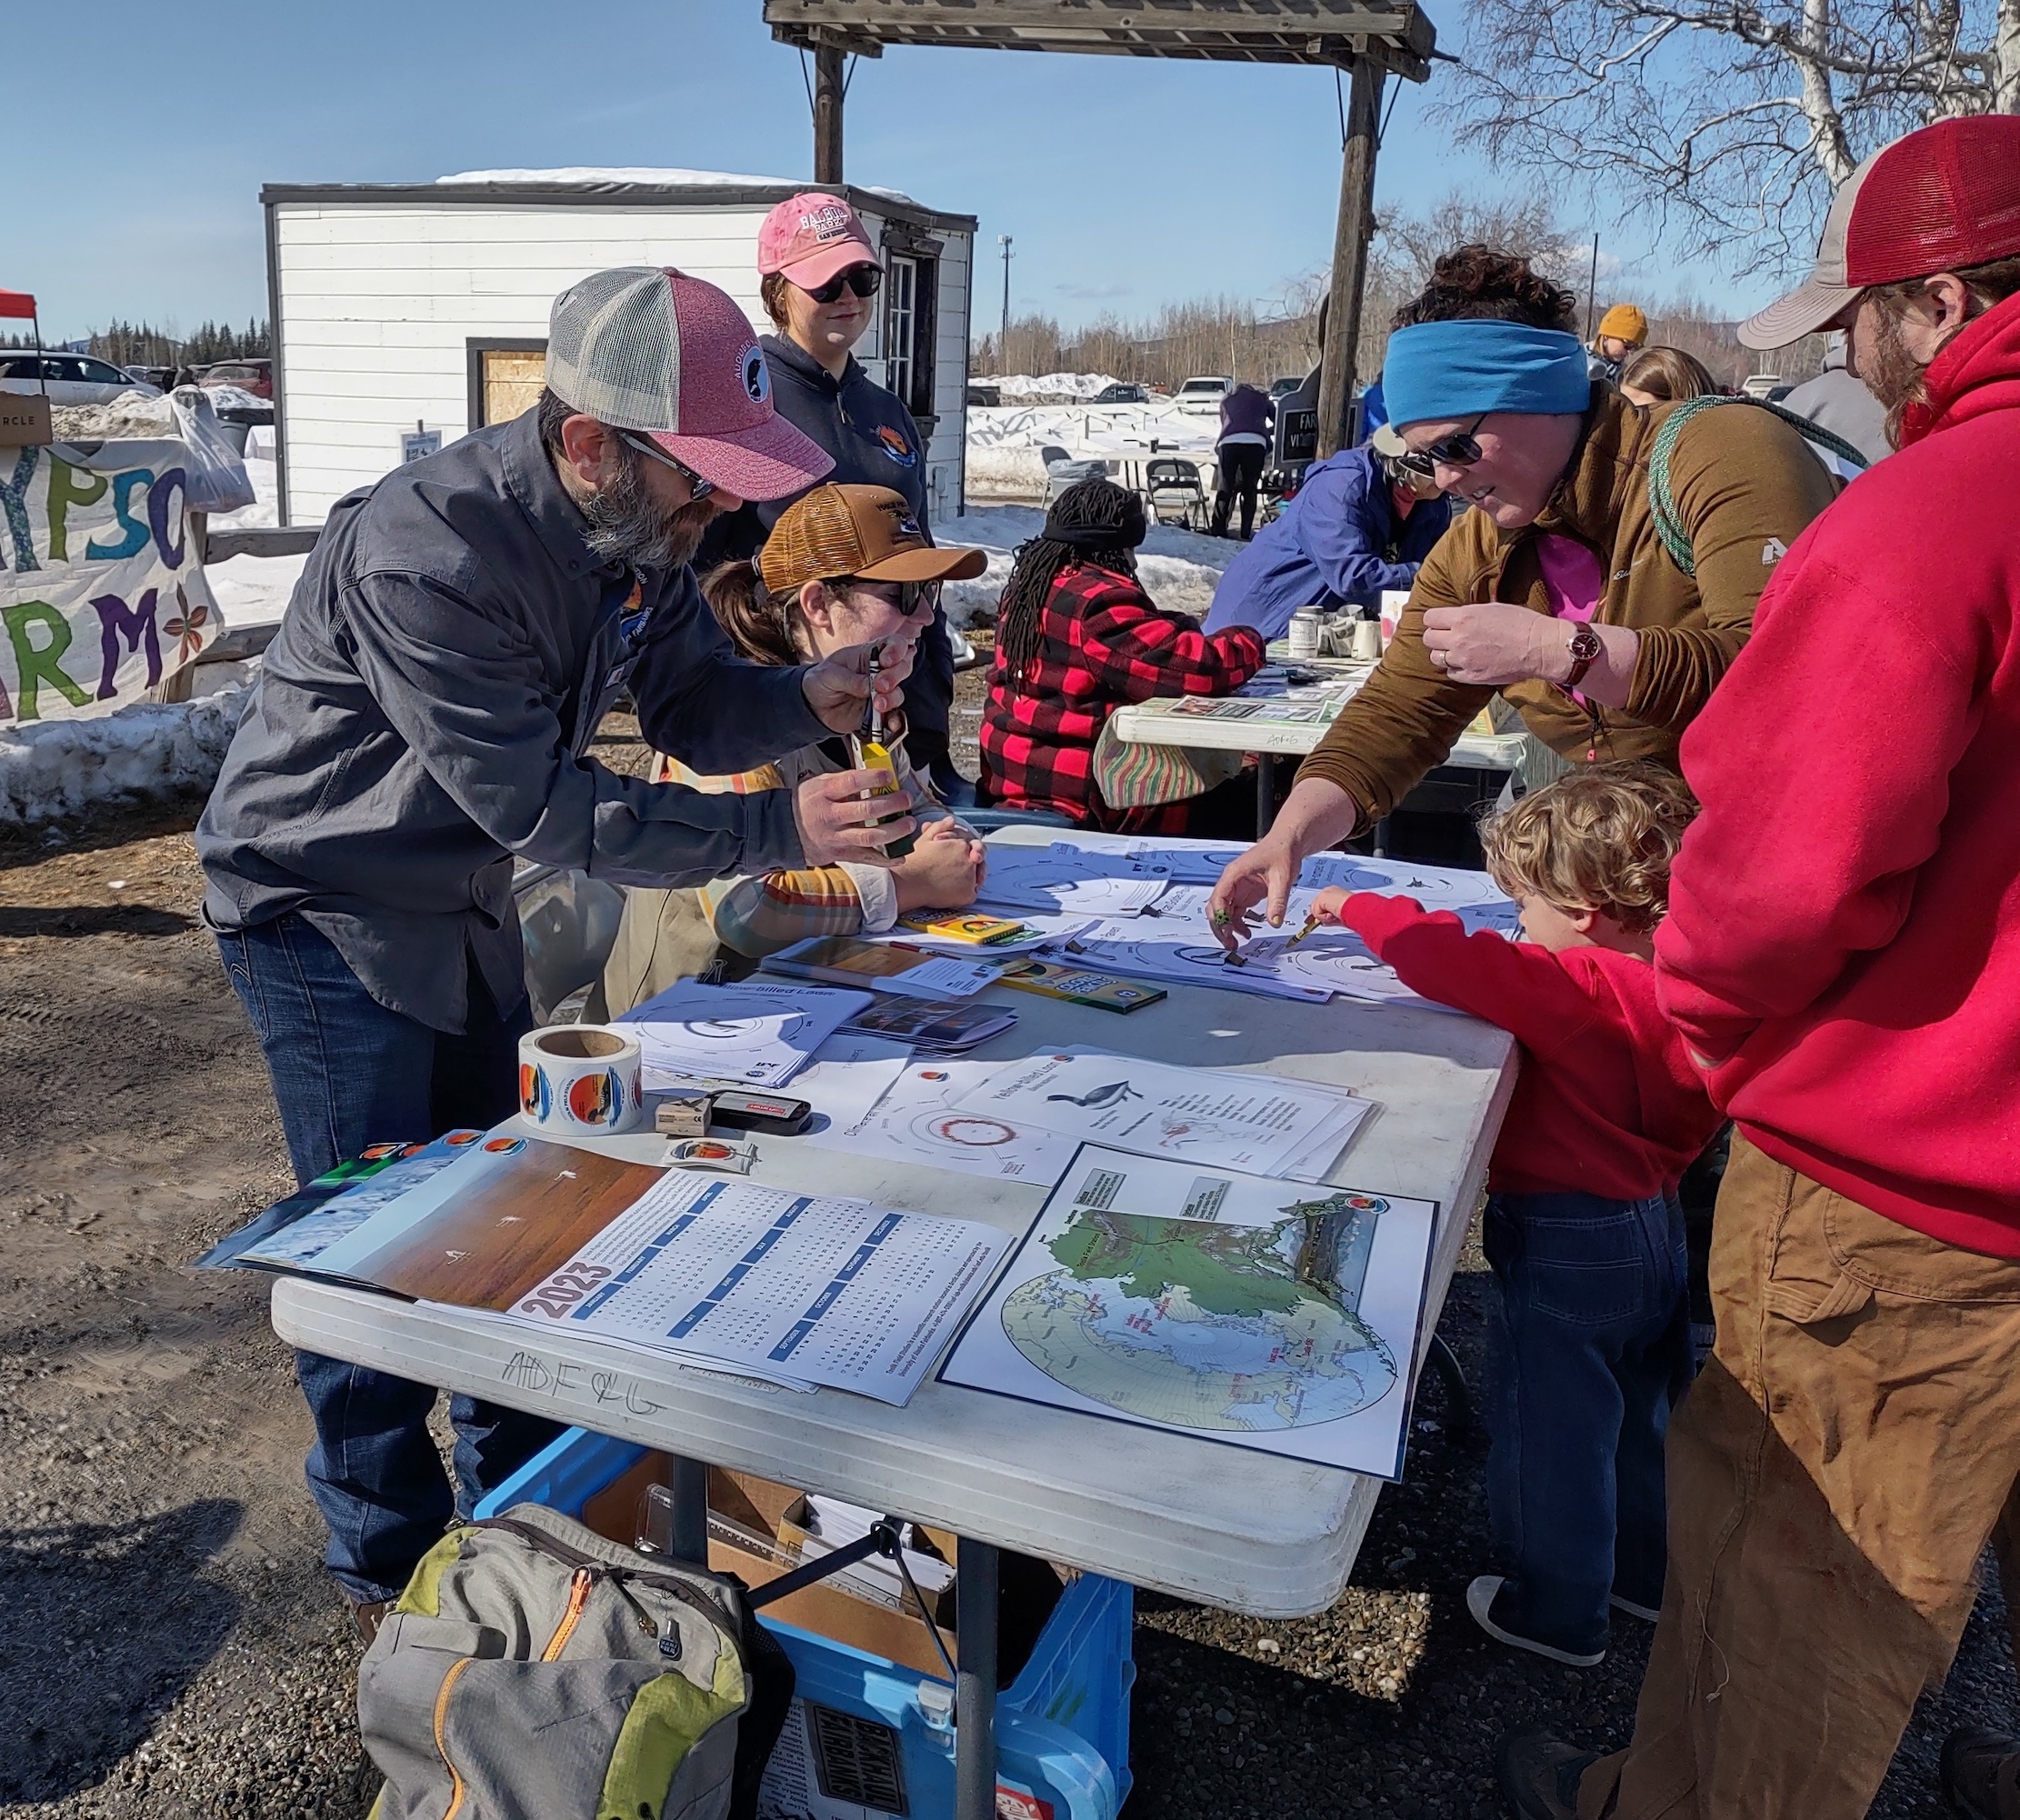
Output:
[{"xmin": 1339, "ymin": 891, "xmax": 1723, "ymax": 1200}]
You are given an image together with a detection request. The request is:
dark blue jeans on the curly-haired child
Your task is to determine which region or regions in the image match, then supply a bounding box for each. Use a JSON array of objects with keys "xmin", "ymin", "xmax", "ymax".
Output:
[{"xmin": 1485, "ymin": 1192, "xmax": 1691, "ymax": 1655}]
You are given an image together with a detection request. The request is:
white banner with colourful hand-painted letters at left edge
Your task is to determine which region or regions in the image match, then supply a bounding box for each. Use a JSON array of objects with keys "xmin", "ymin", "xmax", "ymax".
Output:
[{"xmin": 0, "ymin": 438, "xmax": 222, "ymax": 725}]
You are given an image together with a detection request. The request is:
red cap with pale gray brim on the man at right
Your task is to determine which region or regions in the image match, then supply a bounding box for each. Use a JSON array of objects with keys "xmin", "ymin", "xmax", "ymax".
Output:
[{"xmin": 1739, "ymin": 113, "xmax": 2020, "ymax": 347}]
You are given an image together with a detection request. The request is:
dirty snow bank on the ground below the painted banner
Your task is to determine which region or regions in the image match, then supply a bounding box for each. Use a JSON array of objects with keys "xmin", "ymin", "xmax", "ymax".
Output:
[{"xmin": 0, "ymin": 685, "xmax": 246, "ymax": 822}]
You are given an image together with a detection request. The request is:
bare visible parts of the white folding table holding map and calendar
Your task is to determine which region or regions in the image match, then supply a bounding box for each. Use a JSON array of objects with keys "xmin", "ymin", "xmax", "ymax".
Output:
[{"xmin": 273, "ymin": 826, "xmax": 1515, "ymax": 1820}]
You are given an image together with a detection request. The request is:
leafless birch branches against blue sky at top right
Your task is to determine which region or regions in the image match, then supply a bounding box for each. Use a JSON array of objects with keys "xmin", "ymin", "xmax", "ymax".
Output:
[{"xmin": 1448, "ymin": 0, "xmax": 2020, "ymax": 271}]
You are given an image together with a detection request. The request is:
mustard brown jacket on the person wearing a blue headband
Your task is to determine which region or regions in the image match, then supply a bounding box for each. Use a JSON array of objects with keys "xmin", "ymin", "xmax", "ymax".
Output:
[{"xmin": 1299, "ymin": 384, "xmax": 1838, "ymax": 828}]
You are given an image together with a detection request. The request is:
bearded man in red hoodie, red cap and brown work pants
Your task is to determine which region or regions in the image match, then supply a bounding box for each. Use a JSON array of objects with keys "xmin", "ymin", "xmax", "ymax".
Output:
[{"xmin": 1501, "ymin": 115, "xmax": 2020, "ymax": 1820}]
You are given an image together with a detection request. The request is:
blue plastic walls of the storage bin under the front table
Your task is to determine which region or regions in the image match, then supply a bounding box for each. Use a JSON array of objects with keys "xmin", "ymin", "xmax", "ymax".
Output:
[{"xmin": 476, "ymin": 1428, "xmax": 1135, "ymax": 1820}]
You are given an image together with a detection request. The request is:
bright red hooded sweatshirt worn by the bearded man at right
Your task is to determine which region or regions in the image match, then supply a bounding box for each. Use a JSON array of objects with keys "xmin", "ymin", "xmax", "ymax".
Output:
[{"xmin": 1656, "ymin": 297, "xmax": 2020, "ymax": 1256}]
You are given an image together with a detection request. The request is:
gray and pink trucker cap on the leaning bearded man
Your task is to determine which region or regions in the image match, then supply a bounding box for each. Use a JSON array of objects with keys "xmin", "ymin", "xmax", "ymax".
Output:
[{"xmin": 547, "ymin": 265, "xmax": 835, "ymax": 499}]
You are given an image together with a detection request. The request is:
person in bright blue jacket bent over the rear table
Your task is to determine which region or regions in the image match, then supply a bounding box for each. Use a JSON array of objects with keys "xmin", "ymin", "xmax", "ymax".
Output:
[{"xmin": 1206, "ymin": 426, "xmax": 1453, "ymax": 638}]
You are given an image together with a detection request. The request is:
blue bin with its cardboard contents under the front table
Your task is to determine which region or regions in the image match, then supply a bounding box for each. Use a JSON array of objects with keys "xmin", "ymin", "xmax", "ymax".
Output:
[{"xmin": 476, "ymin": 1428, "xmax": 1135, "ymax": 1820}]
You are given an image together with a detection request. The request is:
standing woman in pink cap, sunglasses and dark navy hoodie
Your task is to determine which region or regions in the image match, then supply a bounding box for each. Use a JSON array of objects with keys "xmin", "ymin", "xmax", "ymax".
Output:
[{"xmin": 697, "ymin": 190, "xmax": 965, "ymax": 800}]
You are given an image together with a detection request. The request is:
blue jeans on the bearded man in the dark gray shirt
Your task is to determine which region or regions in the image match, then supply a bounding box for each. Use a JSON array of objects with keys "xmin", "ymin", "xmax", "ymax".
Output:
[{"xmin": 218, "ymin": 915, "xmax": 559, "ymax": 1602}]
